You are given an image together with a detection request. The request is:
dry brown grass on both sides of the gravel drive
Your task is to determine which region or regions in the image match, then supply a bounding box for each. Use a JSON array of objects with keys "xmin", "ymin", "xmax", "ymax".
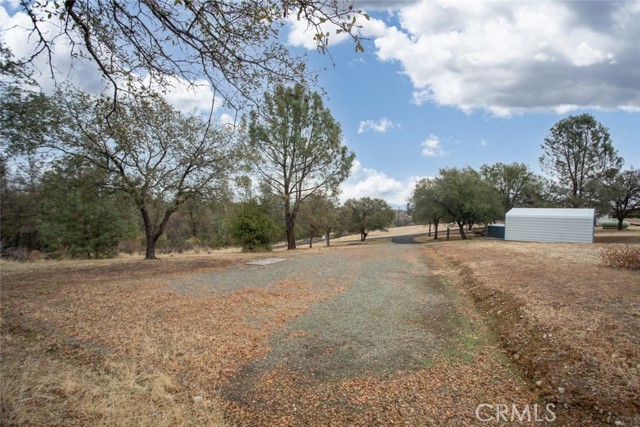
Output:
[{"xmin": 0, "ymin": 226, "xmax": 640, "ymax": 426}]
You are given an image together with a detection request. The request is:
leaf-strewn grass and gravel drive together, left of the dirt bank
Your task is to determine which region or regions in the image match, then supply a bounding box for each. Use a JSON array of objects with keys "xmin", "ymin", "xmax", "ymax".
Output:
[{"xmin": 0, "ymin": 241, "xmax": 537, "ymax": 426}]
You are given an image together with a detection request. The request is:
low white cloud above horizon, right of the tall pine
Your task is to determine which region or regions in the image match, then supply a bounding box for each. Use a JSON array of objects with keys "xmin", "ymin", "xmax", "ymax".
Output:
[{"xmin": 340, "ymin": 160, "xmax": 421, "ymax": 208}]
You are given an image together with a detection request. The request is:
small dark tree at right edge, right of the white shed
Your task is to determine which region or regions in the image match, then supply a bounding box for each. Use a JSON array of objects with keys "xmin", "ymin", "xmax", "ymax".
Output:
[{"xmin": 604, "ymin": 169, "xmax": 640, "ymax": 230}]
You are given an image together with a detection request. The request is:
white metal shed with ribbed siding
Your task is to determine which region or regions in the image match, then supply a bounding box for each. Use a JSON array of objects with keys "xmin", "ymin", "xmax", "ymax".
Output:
[{"xmin": 505, "ymin": 208, "xmax": 595, "ymax": 243}]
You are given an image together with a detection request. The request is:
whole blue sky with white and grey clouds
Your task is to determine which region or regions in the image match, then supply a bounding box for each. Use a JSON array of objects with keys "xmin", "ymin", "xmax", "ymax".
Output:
[{"xmin": 0, "ymin": 0, "xmax": 640, "ymax": 208}]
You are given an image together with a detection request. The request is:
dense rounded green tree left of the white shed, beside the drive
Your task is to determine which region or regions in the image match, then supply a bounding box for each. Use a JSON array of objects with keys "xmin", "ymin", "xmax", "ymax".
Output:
[{"xmin": 434, "ymin": 167, "xmax": 503, "ymax": 239}]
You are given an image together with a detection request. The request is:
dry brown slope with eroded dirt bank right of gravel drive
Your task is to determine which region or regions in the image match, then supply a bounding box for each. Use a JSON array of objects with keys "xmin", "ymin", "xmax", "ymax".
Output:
[{"xmin": 427, "ymin": 241, "xmax": 640, "ymax": 425}]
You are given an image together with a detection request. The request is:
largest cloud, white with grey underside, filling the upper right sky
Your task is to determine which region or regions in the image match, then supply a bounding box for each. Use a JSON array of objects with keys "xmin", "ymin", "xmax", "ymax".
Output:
[{"xmin": 288, "ymin": 0, "xmax": 640, "ymax": 116}]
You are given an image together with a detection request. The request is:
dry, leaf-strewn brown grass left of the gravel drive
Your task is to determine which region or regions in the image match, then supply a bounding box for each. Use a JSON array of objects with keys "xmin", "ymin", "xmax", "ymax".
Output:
[{"xmin": 0, "ymin": 255, "xmax": 339, "ymax": 426}]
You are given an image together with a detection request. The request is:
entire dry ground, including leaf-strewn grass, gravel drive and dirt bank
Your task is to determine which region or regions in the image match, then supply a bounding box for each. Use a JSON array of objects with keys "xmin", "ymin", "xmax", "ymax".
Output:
[{"xmin": 0, "ymin": 228, "xmax": 640, "ymax": 426}]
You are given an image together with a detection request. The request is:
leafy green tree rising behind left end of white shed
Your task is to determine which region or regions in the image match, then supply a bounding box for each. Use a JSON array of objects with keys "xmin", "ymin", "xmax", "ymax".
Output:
[{"xmin": 480, "ymin": 162, "xmax": 542, "ymax": 212}]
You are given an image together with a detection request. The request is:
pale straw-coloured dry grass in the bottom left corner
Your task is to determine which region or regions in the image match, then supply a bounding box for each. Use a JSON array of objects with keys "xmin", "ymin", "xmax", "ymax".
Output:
[{"xmin": 0, "ymin": 331, "xmax": 226, "ymax": 426}]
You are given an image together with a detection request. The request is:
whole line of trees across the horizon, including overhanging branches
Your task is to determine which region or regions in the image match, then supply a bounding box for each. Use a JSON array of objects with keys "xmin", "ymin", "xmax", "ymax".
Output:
[{"xmin": 0, "ymin": 0, "xmax": 639, "ymax": 259}]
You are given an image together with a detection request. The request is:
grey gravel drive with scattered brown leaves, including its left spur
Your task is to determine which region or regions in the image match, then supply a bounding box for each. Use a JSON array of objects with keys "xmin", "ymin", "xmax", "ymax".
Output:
[{"xmin": 161, "ymin": 239, "xmax": 533, "ymax": 427}]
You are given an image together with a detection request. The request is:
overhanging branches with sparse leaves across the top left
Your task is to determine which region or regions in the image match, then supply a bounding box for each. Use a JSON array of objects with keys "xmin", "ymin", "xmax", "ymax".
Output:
[{"xmin": 21, "ymin": 0, "xmax": 368, "ymax": 108}]
